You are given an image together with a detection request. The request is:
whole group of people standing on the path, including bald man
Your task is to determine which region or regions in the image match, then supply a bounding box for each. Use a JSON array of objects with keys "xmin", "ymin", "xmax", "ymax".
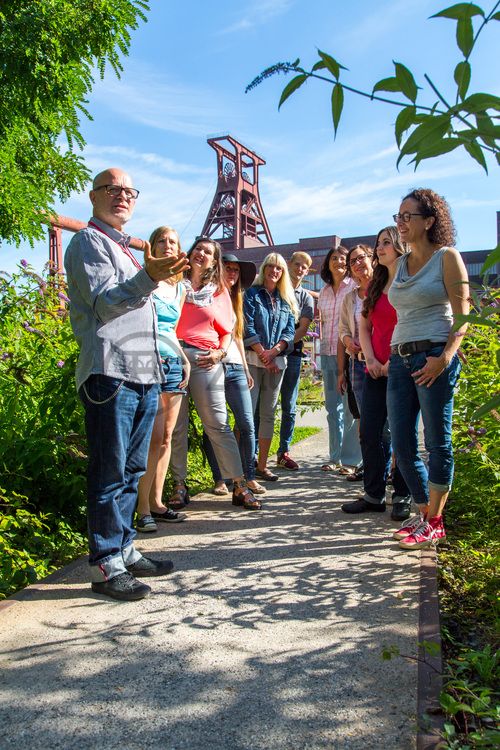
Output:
[{"xmin": 65, "ymin": 168, "xmax": 468, "ymax": 600}]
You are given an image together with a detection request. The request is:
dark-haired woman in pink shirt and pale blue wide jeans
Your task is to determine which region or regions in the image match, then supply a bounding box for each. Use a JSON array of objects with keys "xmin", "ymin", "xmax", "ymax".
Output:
[{"xmin": 318, "ymin": 245, "xmax": 361, "ymax": 471}]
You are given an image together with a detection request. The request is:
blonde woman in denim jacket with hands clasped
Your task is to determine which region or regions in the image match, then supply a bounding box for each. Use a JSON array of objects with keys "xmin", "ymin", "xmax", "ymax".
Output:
[{"xmin": 243, "ymin": 253, "xmax": 299, "ymax": 481}]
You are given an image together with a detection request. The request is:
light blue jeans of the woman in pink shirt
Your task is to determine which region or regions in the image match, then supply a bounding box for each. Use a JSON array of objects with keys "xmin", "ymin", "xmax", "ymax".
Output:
[{"xmin": 321, "ymin": 354, "xmax": 361, "ymax": 466}]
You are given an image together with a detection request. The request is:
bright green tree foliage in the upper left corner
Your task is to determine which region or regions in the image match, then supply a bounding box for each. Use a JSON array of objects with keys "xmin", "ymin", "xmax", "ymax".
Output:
[{"xmin": 0, "ymin": 0, "xmax": 149, "ymax": 244}]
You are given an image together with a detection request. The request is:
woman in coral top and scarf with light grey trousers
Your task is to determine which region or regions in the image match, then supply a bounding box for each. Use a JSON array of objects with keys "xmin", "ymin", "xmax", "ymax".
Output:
[{"xmin": 169, "ymin": 237, "xmax": 261, "ymax": 510}]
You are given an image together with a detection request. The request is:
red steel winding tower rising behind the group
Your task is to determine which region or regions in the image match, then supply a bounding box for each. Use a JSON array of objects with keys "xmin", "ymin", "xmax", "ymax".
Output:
[{"xmin": 202, "ymin": 135, "xmax": 274, "ymax": 252}]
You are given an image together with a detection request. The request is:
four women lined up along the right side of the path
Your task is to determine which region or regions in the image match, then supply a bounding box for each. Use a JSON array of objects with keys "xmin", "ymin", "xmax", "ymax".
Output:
[{"xmin": 319, "ymin": 189, "xmax": 469, "ymax": 549}]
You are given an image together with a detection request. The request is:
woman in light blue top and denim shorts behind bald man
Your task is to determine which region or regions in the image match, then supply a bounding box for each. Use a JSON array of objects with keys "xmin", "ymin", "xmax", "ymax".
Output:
[{"xmin": 137, "ymin": 226, "xmax": 190, "ymax": 532}]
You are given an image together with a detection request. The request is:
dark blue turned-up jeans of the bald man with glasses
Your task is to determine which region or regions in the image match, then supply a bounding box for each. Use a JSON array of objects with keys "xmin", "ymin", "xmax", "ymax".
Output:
[{"xmin": 79, "ymin": 375, "xmax": 159, "ymax": 582}]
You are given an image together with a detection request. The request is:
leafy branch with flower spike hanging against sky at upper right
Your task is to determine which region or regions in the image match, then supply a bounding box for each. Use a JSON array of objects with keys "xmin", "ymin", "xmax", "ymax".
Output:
[{"xmin": 246, "ymin": 2, "xmax": 500, "ymax": 172}]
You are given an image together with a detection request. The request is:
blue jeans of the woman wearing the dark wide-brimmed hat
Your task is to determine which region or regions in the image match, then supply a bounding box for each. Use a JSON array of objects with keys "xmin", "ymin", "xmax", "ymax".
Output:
[{"xmin": 203, "ymin": 364, "xmax": 255, "ymax": 482}]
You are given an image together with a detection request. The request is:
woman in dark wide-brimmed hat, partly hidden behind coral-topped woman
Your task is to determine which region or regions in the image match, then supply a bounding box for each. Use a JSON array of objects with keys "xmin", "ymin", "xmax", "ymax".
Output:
[{"xmin": 203, "ymin": 253, "xmax": 266, "ymax": 495}]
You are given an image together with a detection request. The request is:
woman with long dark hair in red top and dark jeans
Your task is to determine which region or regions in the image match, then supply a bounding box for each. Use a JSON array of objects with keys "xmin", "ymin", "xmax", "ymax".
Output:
[{"xmin": 341, "ymin": 227, "xmax": 411, "ymax": 521}]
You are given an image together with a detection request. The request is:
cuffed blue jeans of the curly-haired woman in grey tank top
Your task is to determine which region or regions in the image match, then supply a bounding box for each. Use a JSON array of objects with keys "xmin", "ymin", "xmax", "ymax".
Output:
[{"xmin": 387, "ymin": 345, "xmax": 461, "ymax": 505}]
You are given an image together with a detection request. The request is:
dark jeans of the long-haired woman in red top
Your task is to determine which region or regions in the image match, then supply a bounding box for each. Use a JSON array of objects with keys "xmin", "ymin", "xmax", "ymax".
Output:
[{"xmin": 359, "ymin": 373, "xmax": 410, "ymax": 505}]
